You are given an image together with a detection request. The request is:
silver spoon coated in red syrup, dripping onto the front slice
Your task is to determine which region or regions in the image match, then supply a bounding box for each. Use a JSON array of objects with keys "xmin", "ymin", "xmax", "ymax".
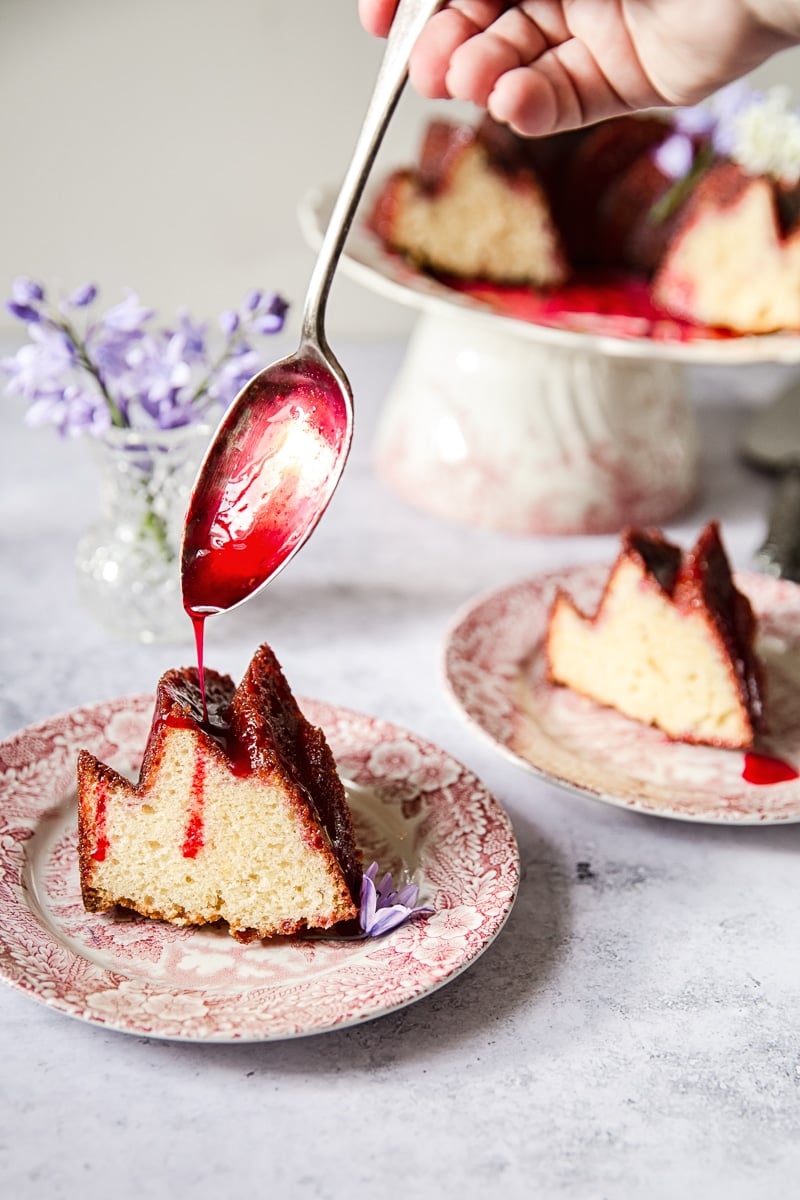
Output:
[{"xmin": 181, "ymin": 0, "xmax": 444, "ymax": 628}]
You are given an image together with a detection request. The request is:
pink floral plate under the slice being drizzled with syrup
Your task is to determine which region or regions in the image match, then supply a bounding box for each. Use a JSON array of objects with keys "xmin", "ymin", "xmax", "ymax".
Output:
[{"xmin": 0, "ymin": 696, "xmax": 519, "ymax": 1042}]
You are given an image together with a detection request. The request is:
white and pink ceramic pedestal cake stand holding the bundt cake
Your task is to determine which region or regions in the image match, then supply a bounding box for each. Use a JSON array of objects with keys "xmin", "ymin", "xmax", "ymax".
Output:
[{"xmin": 300, "ymin": 188, "xmax": 800, "ymax": 534}]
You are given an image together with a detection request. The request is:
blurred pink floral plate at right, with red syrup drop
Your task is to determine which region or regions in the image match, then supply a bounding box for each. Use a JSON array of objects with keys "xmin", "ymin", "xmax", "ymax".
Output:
[{"xmin": 444, "ymin": 565, "xmax": 800, "ymax": 824}]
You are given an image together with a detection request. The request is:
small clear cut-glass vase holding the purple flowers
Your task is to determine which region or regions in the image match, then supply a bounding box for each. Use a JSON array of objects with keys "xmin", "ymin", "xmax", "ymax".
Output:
[{"xmin": 76, "ymin": 425, "xmax": 211, "ymax": 642}]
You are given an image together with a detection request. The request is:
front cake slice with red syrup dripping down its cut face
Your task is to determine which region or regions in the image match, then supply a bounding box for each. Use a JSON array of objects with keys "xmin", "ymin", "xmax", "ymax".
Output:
[{"xmin": 78, "ymin": 646, "xmax": 361, "ymax": 941}]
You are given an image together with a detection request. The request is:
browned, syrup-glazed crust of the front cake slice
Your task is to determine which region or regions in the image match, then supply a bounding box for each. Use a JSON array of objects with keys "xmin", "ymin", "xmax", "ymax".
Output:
[{"xmin": 78, "ymin": 646, "xmax": 361, "ymax": 941}]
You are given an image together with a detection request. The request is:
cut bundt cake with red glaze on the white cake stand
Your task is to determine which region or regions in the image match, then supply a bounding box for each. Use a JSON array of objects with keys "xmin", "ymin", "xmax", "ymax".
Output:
[{"xmin": 369, "ymin": 87, "xmax": 800, "ymax": 334}]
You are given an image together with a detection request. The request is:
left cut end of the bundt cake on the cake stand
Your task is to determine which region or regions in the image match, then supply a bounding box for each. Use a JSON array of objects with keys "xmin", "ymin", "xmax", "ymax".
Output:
[{"xmin": 372, "ymin": 120, "xmax": 567, "ymax": 287}]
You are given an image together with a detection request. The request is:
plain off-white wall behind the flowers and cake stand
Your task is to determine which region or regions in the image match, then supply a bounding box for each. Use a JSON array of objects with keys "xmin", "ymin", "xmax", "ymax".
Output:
[{"xmin": 0, "ymin": 0, "xmax": 800, "ymax": 338}]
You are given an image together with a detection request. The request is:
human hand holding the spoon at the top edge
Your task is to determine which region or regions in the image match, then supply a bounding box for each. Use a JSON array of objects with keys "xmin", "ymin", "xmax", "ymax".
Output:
[{"xmin": 359, "ymin": 0, "xmax": 800, "ymax": 136}]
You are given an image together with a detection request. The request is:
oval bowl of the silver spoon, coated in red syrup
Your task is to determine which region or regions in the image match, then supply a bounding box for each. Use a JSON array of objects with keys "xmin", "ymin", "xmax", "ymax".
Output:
[{"xmin": 181, "ymin": 343, "xmax": 353, "ymax": 617}]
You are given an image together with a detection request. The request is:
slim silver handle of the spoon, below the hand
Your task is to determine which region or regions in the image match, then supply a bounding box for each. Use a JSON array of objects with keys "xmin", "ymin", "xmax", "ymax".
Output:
[{"xmin": 302, "ymin": 0, "xmax": 444, "ymax": 349}]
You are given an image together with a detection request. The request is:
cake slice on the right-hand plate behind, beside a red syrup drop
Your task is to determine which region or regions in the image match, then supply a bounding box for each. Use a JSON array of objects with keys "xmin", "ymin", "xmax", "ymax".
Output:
[{"xmin": 546, "ymin": 522, "xmax": 763, "ymax": 748}]
